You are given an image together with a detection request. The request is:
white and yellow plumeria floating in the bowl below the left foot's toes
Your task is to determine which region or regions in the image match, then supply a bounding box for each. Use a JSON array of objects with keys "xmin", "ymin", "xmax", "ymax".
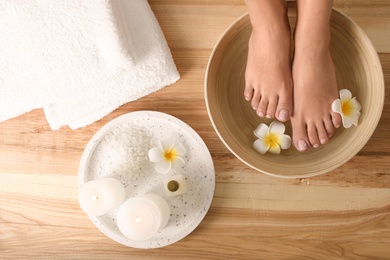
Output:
[{"xmin": 253, "ymin": 121, "xmax": 291, "ymax": 154}]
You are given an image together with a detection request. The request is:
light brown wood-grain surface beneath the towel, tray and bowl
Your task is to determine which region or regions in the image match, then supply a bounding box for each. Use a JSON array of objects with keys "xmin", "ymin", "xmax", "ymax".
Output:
[{"xmin": 0, "ymin": 0, "xmax": 390, "ymax": 259}]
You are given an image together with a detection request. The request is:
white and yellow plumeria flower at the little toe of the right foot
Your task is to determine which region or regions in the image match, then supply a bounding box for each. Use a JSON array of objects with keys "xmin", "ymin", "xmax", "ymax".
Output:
[{"xmin": 332, "ymin": 89, "xmax": 362, "ymax": 128}]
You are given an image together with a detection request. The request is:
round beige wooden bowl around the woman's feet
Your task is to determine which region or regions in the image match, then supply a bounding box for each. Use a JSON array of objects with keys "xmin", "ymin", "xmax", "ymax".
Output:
[{"xmin": 205, "ymin": 8, "xmax": 385, "ymax": 178}]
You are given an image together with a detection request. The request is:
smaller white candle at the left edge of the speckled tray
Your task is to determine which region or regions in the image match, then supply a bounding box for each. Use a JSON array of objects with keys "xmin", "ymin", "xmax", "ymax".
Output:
[{"xmin": 79, "ymin": 178, "xmax": 126, "ymax": 216}]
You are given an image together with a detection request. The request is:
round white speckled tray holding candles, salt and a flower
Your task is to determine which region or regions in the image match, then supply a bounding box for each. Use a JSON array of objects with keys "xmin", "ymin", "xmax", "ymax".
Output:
[{"xmin": 79, "ymin": 111, "xmax": 215, "ymax": 248}]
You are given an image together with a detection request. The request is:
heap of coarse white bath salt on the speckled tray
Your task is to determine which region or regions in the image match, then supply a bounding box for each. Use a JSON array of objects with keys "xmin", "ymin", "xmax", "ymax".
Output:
[{"xmin": 93, "ymin": 124, "xmax": 152, "ymax": 177}]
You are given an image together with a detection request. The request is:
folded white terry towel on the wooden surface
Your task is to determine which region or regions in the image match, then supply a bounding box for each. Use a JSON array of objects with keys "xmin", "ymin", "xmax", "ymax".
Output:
[{"xmin": 0, "ymin": 0, "xmax": 179, "ymax": 130}]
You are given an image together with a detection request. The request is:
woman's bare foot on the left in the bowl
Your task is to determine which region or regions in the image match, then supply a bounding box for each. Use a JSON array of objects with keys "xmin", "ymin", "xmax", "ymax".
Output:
[{"xmin": 244, "ymin": 0, "xmax": 292, "ymax": 122}]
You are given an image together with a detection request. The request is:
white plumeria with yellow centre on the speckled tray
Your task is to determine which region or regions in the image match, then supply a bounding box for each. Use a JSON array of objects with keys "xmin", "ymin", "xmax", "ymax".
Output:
[{"xmin": 149, "ymin": 138, "xmax": 186, "ymax": 174}]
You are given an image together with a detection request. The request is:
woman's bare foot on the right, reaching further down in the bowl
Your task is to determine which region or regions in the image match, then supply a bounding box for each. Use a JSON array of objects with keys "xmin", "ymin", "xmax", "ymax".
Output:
[{"xmin": 291, "ymin": 0, "xmax": 341, "ymax": 151}]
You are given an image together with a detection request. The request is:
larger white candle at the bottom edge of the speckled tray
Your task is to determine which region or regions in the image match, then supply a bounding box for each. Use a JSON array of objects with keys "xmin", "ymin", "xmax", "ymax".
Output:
[{"xmin": 117, "ymin": 194, "xmax": 170, "ymax": 241}]
